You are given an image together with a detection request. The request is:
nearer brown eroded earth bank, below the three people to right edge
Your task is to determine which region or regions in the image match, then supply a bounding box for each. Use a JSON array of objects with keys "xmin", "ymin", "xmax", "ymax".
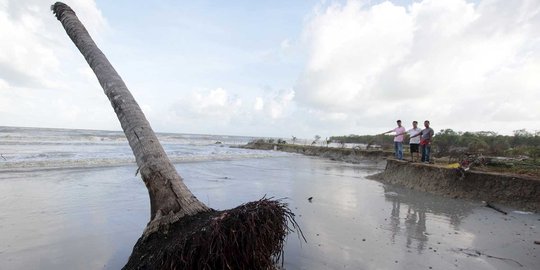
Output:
[{"xmin": 373, "ymin": 159, "xmax": 540, "ymax": 212}]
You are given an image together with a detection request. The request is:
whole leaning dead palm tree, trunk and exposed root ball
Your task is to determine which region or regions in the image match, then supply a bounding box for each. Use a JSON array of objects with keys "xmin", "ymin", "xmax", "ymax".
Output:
[{"xmin": 51, "ymin": 2, "xmax": 301, "ymax": 269}]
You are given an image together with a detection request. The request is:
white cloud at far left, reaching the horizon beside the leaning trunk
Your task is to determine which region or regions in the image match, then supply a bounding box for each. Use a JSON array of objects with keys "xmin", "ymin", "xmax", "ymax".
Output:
[{"xmin": 0, "ymin": 0, "xmax": 119, "ymax": 129}]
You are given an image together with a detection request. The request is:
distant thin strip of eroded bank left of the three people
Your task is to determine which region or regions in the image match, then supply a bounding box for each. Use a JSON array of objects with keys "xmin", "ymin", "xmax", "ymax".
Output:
[{"xmin": 242, "ymin": 142, "xmax": 392, "ymax": 163}]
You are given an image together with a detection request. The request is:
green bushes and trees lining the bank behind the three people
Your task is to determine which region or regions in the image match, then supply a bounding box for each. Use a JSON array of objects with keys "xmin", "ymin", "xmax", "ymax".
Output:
[{"xmin": 250, "ymin": 129, "xmax": 540, "ymax": 177}]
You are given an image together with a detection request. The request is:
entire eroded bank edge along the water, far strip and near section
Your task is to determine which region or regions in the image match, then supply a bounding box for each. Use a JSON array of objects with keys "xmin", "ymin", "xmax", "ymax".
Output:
[{"xmin": 241, "ymin": 142, "xmax": 540, "ymax": 213}]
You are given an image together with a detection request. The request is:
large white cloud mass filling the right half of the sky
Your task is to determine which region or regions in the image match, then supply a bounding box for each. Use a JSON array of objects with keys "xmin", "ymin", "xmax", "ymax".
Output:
[{"xmin": 296, "ymin": 0, "xmax": 540, "ymax": 134}]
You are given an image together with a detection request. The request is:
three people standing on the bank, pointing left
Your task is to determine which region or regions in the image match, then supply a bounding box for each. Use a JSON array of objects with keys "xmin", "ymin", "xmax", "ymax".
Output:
[{"xmin": 381, "ymin": 120, "xmax": 434, "ymax": 163}]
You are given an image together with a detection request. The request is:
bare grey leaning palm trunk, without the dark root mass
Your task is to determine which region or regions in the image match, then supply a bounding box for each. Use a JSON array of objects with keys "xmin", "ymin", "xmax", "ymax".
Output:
[{"xmin": 51, "ymin": 2, "xmax": 210, "ymax": 234}]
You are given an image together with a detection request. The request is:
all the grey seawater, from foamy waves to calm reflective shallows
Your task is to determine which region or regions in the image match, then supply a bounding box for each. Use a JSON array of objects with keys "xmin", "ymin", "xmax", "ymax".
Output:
[{"xmin": 0, "ymin": 127, "xmax": 540, "ymax": 269}]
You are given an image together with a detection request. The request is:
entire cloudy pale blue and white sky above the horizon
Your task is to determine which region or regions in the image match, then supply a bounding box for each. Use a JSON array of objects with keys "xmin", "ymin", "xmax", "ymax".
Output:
[{"xmin": 0, "ymin": 0, "xmax": 540, "ymax": 138}]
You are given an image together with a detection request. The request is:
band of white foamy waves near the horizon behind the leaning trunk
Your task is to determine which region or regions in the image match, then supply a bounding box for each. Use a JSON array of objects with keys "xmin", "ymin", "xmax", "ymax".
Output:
[{"xmin": 0, "ymin": 127, "xmax": 285, "ymax": 171}]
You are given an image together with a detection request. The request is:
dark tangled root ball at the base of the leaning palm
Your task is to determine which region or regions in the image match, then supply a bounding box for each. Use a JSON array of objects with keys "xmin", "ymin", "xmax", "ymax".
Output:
[{"xmin": 124, "ymin": 198, "xmax": 305, "ymax": 269}]
